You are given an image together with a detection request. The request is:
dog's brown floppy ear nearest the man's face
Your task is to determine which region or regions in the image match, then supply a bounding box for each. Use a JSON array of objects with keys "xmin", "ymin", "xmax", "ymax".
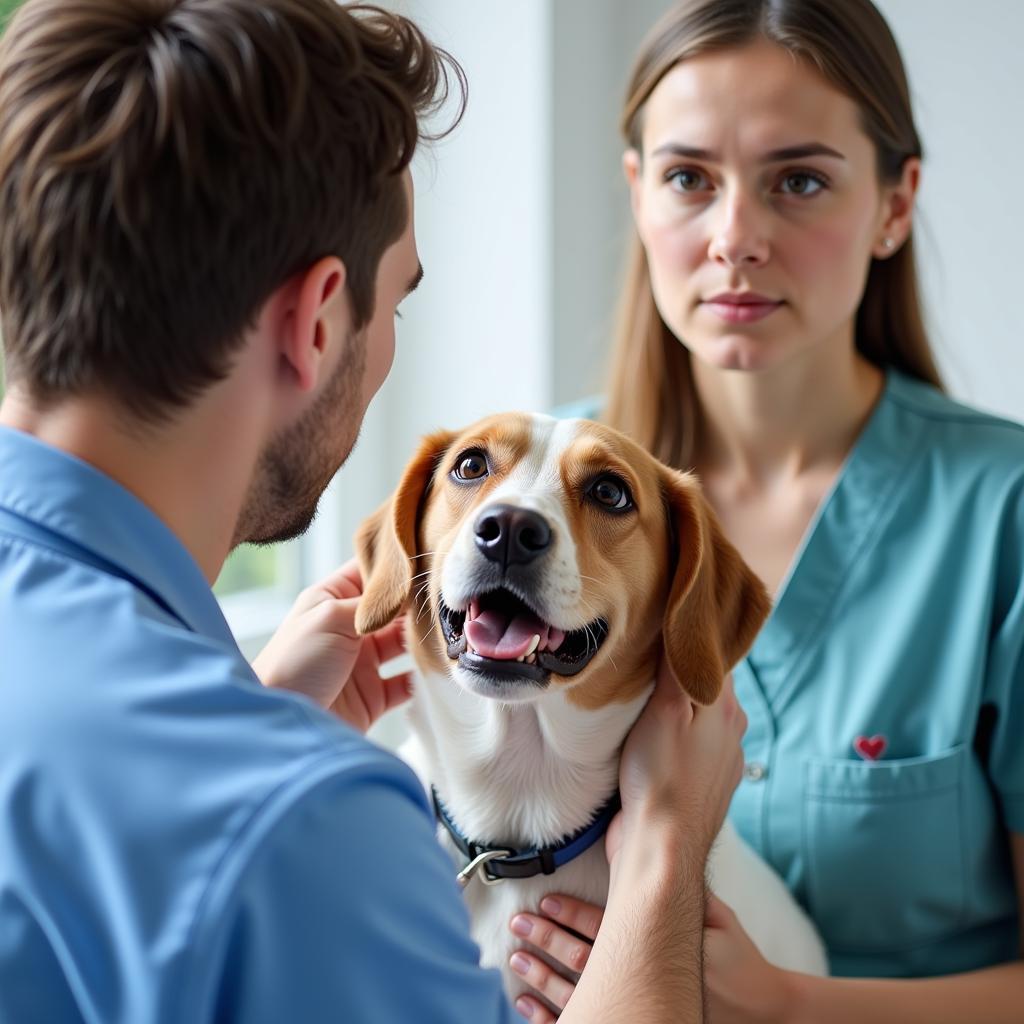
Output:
[{"xmin": 355, "ymin": 431, "xmax": 455, "ymax": 635}]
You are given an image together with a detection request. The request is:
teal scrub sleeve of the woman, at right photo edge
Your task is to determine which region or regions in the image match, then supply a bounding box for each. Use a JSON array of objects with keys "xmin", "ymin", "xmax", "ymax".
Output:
[{"xmin": 984, "ymin": 480, "xmax": 1024, "ymax": 834}]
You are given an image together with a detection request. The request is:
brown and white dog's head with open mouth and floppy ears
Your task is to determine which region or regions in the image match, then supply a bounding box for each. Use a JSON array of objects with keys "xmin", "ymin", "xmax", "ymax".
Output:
[{"xmin": 356, "ymin": 414, "xmax": 769, "ymax": 708}]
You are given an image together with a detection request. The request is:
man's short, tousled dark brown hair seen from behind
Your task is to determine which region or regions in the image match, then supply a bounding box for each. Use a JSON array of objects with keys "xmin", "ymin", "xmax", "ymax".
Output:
[{"xmin": 0, "ymin": 0, "xmax": 466, "ymax": 419}]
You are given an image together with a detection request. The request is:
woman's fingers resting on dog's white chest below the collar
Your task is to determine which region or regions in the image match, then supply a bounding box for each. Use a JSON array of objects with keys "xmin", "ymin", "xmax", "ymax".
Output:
[{"xmin": 509, "ymin": 895, "xmax": 604, "ymax": 1024}]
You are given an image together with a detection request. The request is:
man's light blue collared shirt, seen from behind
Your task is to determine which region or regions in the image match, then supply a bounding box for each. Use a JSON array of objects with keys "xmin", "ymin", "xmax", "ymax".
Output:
[{"xmin": 0, "ymin": 428, "xmax": 516, "ymax": 1024}]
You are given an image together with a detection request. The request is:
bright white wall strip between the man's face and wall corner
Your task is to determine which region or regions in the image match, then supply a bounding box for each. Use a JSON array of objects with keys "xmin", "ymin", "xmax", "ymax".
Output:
[{"xmin": 333, "ymin": 0, "xmax": 552, "ymax": 551}]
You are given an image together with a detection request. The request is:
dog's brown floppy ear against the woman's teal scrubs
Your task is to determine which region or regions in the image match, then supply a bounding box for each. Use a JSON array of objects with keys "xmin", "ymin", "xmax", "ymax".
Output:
[{"xmin": 663, "ymin": 470, "xmax": 771, "ymax": 705}]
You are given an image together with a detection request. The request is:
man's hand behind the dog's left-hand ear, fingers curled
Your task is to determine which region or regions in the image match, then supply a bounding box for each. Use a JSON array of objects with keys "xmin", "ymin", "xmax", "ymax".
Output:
[{"xmin": 253, "ymin": 561, "xmax": 411, "ymax": 732}]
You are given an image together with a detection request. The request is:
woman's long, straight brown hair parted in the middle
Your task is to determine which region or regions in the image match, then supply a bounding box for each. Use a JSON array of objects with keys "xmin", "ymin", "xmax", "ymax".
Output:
[{"xmin": 604, "ymin": 0, "xmax": 942, "ymax": 469}]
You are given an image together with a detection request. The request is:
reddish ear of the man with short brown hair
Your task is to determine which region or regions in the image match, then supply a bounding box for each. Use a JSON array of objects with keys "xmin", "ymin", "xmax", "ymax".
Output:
[{"xmin": 281, "ymin": 256, "xmax": 351, "ymax": 391}]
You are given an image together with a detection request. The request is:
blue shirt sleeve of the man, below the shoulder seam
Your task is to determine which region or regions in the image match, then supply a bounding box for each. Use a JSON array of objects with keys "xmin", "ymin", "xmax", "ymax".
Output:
[{"xmin": 205, "ymin": 761, "xmax": 519, "ymax": 1024}]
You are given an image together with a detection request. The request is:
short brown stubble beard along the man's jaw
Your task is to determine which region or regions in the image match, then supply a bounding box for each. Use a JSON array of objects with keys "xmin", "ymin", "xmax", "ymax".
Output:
[{"xmin": 231, "ymin": 330, "xmax": 367, "ymax": 548}]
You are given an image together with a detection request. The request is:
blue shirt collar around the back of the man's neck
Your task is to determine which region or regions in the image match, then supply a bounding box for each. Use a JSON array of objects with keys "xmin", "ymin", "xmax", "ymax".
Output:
[{"xmin": 0, "ymin": 427, "xmax": 236, "ymax": 647}]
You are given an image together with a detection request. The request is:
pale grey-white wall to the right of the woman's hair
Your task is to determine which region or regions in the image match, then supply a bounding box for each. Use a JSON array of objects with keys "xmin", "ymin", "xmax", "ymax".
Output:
[{"xmin": 877, "ymin": 0, "xmax": 1024, "ymax": 420}]
